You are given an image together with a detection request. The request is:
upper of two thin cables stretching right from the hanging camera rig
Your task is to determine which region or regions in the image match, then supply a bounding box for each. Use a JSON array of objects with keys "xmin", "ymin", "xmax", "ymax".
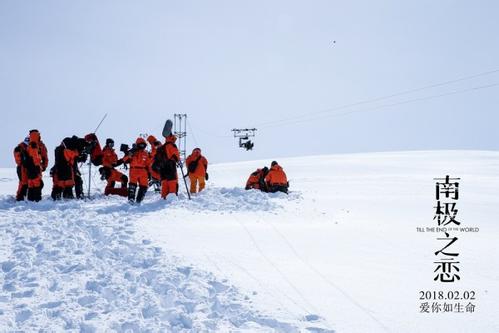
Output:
[{"xmin": 254, "ymin": 69, "xmax": 499, "ymax": 127}]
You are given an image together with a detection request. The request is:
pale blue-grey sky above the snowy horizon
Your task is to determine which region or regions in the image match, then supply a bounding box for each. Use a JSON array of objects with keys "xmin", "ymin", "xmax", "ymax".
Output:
[{"xmin": 0, "ymin": 0, "xmax": 499, "ymax": 167}]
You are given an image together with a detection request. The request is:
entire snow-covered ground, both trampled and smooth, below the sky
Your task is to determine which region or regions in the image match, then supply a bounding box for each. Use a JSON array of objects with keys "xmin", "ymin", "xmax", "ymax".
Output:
[{"xmin": 0, "ymin": 151, "xmax": 499, "ymax": 333}]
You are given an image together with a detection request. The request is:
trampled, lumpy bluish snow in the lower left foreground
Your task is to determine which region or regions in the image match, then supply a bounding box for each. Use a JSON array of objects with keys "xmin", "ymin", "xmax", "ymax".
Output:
[{"xmin": 0, "ymin": 196, "xmax": 316, "ymax": 332}]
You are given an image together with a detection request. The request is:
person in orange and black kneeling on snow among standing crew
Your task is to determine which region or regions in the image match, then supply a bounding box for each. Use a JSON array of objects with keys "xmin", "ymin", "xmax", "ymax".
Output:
[{"xmin": 99, "ymin": 139, "xmax": 128, "ymax": 197}]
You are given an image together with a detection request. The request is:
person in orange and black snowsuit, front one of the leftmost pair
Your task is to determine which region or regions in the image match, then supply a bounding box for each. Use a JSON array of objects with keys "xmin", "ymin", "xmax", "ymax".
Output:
[{"xmin": 24, "ymin": 130, "xmax": 48, "ymax": 201}]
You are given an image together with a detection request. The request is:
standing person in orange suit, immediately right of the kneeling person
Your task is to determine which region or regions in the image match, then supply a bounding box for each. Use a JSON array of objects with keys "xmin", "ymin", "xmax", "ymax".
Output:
[{"xmin": 123, "ymin": 137, "xmax": 151, "ymax": 203}]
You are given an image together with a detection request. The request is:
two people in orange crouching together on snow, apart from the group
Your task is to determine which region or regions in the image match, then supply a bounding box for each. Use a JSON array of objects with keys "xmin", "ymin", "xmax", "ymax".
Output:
[{"xmin": 246, "ymin": 161, "xmax": 289, "ymax": 194}]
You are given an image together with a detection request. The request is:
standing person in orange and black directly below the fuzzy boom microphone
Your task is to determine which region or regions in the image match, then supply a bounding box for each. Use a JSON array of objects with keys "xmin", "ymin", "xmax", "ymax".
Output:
[{"xmin": 152, "ymin": 134, "xmax": 180, "ymax": 199}]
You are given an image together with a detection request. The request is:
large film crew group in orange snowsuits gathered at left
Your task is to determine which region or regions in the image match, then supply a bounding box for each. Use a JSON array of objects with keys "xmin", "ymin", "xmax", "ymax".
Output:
[{"xmin": 14, "ymin": 130, "xmax": 186, "ymax": 202}]
